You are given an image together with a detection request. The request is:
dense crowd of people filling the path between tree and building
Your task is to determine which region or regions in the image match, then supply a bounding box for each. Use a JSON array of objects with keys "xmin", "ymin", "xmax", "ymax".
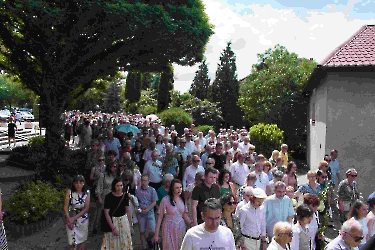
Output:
[{"xmin": 31, "ymin": 112, "xmax": 375, "ymax": 250}]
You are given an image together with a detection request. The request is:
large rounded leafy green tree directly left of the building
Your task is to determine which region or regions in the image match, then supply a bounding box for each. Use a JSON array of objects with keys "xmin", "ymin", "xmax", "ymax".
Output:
[{"xmin": 239, "ymin": 45, "xmax": 316, "ymax": 157}]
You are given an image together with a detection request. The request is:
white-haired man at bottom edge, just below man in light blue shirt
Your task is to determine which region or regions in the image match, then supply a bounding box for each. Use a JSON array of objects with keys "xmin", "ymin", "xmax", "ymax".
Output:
[{"xmin": 267, "ymin": 221, "xmax": 293, "ymax": 250}]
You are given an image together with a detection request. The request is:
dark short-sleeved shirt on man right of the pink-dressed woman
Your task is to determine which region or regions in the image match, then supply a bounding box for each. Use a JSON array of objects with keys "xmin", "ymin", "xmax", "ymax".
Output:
[{"xmin": 191, "ymin": 182, "xmax": 220, "ymax": 219}]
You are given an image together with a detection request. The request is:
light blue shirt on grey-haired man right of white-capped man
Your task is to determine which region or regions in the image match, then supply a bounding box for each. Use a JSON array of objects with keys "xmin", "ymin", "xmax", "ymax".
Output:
[{"xmin": 264, "ymin": 194, "xmax": 294, "ymax": 237}]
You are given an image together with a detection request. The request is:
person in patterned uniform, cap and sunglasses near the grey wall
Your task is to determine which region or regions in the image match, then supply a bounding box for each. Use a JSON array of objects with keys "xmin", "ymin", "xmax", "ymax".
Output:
[{"xmin": 337, "ymin": 168, "xmax": 360, "ymax": 223}]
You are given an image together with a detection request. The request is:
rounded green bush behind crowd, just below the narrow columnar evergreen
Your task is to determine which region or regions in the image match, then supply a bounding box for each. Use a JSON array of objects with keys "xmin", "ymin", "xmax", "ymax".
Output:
[{"xmin": 158, "ymin": 108, "xmax": 193, "ymax": 133}]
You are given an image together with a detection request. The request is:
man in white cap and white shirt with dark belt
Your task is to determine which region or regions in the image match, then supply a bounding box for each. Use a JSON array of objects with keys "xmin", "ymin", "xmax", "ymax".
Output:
[{"xmin": 239, "ymin": 188, "xmax": 267, "ymax": 250}]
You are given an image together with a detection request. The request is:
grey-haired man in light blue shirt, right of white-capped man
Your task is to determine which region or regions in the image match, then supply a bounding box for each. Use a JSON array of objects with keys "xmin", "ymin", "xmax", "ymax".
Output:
[{"xmin": 264, "ymin": 181, "xmax": 294, "ymax": 237}]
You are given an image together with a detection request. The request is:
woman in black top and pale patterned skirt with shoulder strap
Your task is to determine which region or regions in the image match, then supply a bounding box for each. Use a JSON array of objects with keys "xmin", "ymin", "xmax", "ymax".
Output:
[{"xmin": 101, "ymin": 179, "xmax": 133, "ymax": 250}]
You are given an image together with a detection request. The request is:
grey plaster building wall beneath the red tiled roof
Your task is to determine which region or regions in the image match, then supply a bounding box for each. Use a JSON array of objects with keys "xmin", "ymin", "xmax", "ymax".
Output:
[{"xmin": 319, "ymin": 72, "xmax": 375, "ymax": 199}]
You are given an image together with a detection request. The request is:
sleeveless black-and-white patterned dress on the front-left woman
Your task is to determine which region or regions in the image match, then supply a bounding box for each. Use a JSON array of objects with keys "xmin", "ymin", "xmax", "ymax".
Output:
[{"xmin": 66, "ymin": 190, "xmax": 90, "ymax": 245}]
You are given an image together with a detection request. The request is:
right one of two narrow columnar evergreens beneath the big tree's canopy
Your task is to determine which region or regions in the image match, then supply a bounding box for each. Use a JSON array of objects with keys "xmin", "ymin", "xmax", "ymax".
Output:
[{"xmin": 157, "ymin": 63, "xmax": 174, "ymax": 112}]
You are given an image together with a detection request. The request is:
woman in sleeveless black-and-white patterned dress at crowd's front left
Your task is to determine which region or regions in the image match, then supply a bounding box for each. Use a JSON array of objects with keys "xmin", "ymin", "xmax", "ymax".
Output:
[{"xmin": 64, "ymin": 175, "xmax": 90, "ymax": 250}]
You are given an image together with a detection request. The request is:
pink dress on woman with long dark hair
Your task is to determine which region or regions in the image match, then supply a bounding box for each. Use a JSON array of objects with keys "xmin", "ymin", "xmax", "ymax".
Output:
[{"xmin": 159, "ymin": 196, "xmax": 186, "ymax": 250}]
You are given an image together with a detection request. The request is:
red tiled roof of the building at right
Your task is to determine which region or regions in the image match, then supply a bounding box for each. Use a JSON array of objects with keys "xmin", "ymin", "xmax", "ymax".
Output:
[{"xmin": 320, "ymin": 25, "xmax": 375, "ymax": 66}]
